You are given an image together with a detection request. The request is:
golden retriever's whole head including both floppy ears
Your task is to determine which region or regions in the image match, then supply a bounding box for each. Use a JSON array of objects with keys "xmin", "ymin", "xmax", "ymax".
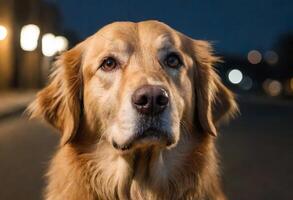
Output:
[{"xmin": 29, "ymin": 21, "xmax": 237, "ymax": 151}]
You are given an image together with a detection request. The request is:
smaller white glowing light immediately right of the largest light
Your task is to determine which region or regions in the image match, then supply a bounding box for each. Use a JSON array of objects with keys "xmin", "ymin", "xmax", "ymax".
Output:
[{"xmin": 42, "ymin": 33, "xmax": 57, "ymax": 57}]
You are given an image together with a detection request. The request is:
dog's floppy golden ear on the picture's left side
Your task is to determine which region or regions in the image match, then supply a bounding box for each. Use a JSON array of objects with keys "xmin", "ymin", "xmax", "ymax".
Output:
[{"xmin": 27, "ymin": 43, "xmax": 84, "ymax": 145}]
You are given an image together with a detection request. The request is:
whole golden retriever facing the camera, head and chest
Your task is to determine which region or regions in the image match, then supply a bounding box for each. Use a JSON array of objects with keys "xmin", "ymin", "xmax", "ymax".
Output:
[{"xmin": 28, "ymin": 20, "xmax": 237, "ymax": 200}]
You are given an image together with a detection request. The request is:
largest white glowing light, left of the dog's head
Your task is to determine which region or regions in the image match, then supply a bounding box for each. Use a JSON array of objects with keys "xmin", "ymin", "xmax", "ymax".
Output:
[{"xmin": 20, "ymin": 24, "xmax": 40, "ymax": 51}]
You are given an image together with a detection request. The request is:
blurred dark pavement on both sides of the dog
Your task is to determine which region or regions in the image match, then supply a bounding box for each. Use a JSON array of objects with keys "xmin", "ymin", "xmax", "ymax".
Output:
[{"xmin": 0, "ymin": 96, "xmax": 293, "ymax": 200}]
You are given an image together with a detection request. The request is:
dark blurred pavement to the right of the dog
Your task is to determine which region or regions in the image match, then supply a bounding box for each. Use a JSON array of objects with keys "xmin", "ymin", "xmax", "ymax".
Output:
[{"xmin": 219, "ymin": 100, "xmax": 293, "ymax": 200}]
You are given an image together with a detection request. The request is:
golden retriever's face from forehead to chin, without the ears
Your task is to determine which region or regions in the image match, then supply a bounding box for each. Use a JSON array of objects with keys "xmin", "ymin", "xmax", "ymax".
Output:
[{"xmin": 83, "ymin": 22, "xmax": 193, "ymax": 150}]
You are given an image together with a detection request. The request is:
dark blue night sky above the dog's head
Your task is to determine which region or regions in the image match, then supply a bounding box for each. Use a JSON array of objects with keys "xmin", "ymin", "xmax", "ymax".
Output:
[{"xmin": 47, "ymin": 0, "xmax": 293, "ymax": 55}]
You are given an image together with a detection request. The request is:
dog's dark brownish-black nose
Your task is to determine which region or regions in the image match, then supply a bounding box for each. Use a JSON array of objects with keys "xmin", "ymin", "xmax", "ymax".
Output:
[{"xmin": 132, "ymin": 85, "xmax": 169, "ymax": 115}]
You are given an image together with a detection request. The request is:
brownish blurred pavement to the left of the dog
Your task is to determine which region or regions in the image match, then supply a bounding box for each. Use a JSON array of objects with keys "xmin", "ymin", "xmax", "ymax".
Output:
[{"xmin": 0, "ymin": 117, "xmax": 58, "ymax": 200}]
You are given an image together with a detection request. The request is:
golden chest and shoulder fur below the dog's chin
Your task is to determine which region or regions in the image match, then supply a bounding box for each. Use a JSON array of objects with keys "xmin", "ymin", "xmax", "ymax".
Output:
[{"xmin": 46, "ymin": 138, "xmax": 221, "ymax": 200}]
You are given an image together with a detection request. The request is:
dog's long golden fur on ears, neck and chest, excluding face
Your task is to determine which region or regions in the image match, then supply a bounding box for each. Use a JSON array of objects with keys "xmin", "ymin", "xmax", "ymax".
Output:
[{"xmin": 28, "ymin": 21, "xmax": 237, "ymax": 200}]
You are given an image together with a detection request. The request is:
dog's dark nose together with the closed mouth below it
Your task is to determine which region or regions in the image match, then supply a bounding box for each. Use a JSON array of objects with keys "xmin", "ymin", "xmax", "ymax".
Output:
[{"xmin": 112, "ymin": 85, "xmax": 174, "ymax": 151}]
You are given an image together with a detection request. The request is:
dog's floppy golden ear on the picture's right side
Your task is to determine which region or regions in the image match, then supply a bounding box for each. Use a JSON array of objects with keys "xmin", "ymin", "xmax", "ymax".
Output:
[{"xmin": 193, "ymin": 40, "xmax": 238, "ymax": 136}]
